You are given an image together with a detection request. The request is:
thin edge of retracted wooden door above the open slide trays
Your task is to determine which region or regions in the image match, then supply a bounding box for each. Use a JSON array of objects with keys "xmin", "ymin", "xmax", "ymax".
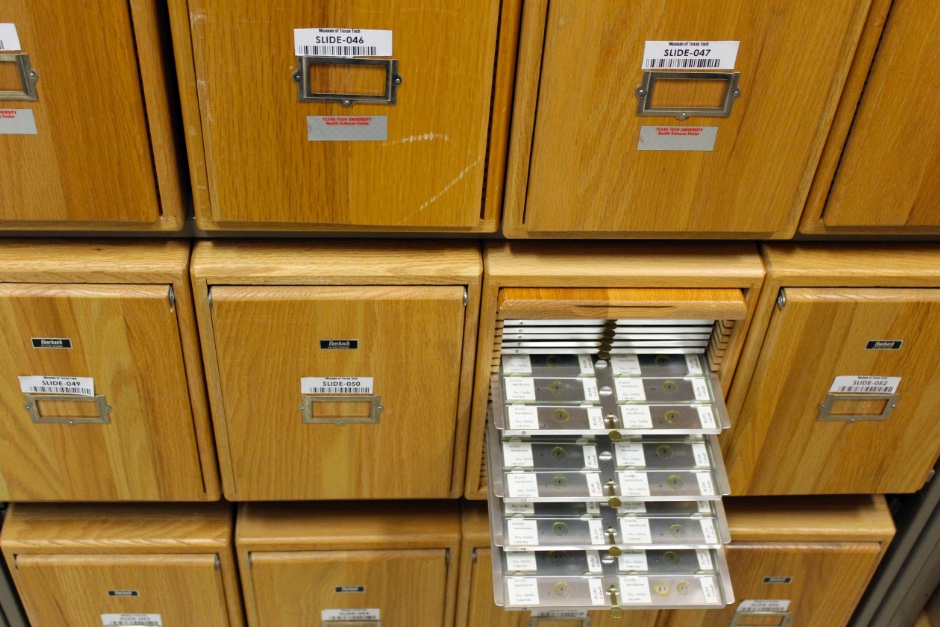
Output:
[{"xmin": 498, "ymin": 288, "xmax": 747, "ymax": 320}]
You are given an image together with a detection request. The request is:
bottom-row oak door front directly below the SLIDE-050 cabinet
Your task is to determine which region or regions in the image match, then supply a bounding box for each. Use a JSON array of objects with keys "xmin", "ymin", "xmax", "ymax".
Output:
[{"xmin": 249, "ymin": 549, "xmax": 447, "ymax": 627}]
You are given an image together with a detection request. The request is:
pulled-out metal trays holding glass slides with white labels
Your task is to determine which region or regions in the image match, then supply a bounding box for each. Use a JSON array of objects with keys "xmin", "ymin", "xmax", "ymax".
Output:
[{"xmin": 487, "ymin": 349, "xmax": 734, "ymax": 615}]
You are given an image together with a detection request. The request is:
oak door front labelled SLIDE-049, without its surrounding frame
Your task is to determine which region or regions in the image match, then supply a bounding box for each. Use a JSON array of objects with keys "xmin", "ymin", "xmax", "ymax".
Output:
[{"xmin": 0, "ymin": 283, "xmax": 205, "ymax": 501}]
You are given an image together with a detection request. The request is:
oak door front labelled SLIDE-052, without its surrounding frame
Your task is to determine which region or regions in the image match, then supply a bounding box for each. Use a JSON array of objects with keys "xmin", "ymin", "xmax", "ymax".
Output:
[{"xmin": 725, "ymin": 288, "xmax": 940, "ymax": 495}]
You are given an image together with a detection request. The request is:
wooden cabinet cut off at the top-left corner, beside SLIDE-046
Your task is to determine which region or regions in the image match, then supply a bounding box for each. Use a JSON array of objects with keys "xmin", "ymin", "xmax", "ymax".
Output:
[{"xmin": 0, "ymin": 0, "xmax": 187, "ymax": 230}]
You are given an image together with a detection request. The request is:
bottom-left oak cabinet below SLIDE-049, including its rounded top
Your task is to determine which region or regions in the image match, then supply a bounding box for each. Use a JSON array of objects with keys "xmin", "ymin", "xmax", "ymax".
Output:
[{"xmin": 0, "ymin": 503, "xmax": 243, "ymax": 626}]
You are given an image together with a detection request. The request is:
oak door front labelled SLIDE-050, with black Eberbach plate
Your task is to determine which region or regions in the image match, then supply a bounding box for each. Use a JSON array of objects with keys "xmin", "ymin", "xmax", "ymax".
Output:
[{"xmin": 211, "ymin": 286, "xmax": 465, "ymax": 500}]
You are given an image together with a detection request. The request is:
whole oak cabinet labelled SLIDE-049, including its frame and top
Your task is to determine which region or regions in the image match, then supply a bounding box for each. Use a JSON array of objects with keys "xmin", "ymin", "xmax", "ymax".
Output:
[{"xmin": 0, "ymin": 240, "xmax": 219, "ymax": 501}]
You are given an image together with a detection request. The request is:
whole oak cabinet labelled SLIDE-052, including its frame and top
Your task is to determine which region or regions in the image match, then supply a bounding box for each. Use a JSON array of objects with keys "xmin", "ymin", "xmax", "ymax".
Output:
[{"xmin": 722, "ymin": 244, "xmax": 940, "ymax": 495}]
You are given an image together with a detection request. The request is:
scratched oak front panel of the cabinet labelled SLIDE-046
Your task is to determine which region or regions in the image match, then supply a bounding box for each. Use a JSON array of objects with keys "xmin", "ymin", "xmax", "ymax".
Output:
[{"xmin": 187, "ymin": 0, "xmax": 504, "ymax": 231}]
